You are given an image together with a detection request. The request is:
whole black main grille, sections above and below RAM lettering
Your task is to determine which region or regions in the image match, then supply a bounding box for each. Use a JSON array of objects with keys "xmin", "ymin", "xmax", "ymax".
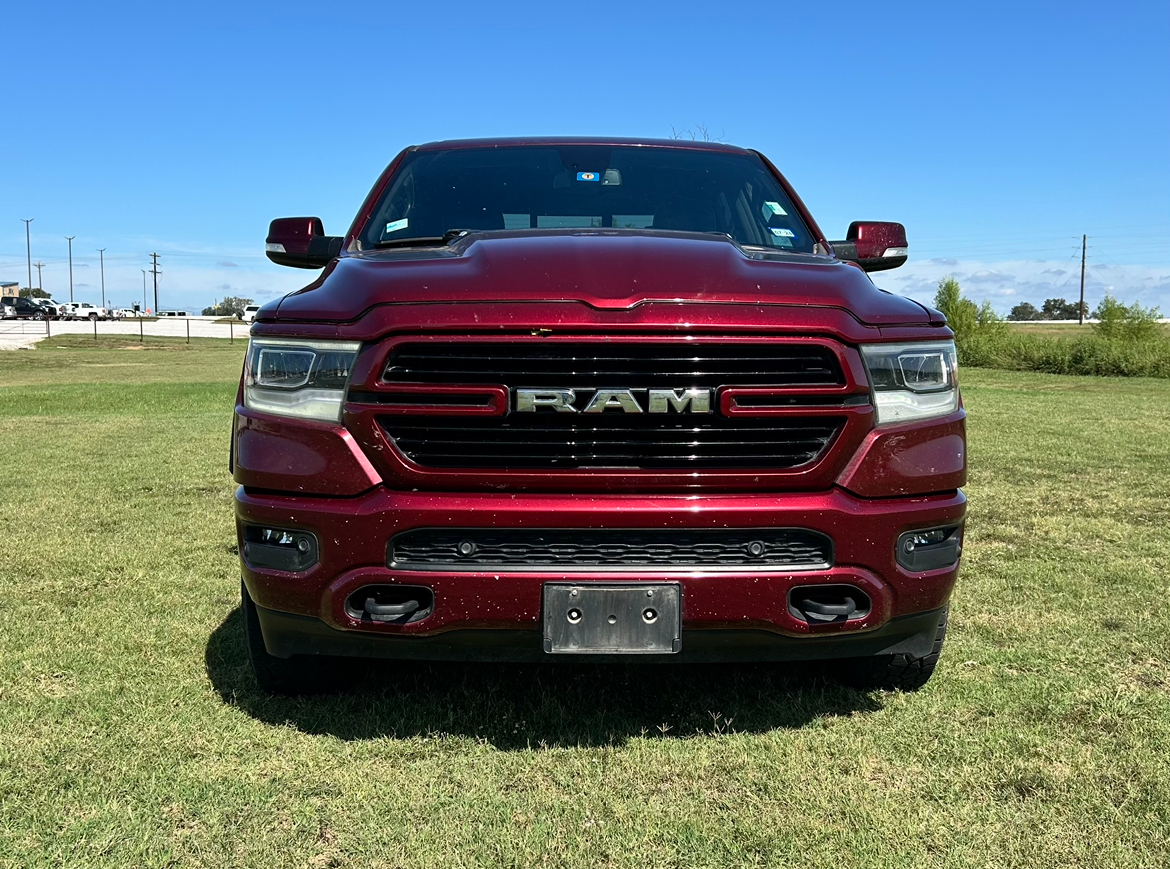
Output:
[{"xmin": 374, "ymin": 338, "xmax": 846, "ymax": 470}]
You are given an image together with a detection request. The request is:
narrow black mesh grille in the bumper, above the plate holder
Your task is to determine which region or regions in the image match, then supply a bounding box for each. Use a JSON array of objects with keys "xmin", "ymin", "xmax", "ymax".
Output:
[{"xmin": 388, "ymin": 529, "xmax": 833, "ymax": 571}]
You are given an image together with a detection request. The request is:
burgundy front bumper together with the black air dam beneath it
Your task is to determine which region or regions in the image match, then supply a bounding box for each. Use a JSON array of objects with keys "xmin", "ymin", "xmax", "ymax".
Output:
[{"xmin": 236, "ymin": 488, "xmax": 966, "ymax": 661}]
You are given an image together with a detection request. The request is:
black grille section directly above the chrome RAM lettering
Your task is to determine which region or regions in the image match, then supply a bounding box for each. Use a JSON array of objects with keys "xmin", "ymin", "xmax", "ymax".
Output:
[{"xmin": 384, "ymin": 340, "xmax": 844, "ymax": 389}]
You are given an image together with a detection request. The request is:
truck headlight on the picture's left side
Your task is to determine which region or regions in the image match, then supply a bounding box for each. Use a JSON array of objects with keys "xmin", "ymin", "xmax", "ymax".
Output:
[{"xmin": 243, "ymin": 338, "xmax": 362, "ymax": 422}]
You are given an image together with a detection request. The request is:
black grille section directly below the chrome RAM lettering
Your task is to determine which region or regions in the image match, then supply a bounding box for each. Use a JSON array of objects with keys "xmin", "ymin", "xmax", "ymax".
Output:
[{"xmin": 380, "ymin": 413, "xmax": 845, "ymax": 469}]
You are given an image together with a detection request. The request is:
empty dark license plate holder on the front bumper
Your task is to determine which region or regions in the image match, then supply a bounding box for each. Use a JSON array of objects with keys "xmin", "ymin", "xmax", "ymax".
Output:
[{"xmin": 544, "ymin": 582, "xmax": 682, "ymax": 655}]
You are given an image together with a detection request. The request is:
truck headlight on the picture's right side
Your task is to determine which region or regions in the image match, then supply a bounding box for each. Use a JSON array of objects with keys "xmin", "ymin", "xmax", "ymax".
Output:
[{"xmin": 861, "ymin": 342, "xmax": 958, "ymax": 426}]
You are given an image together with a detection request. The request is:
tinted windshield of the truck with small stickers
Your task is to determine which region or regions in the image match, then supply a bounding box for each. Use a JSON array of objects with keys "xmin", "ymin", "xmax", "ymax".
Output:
[{"xmin": 358, "ymin": 145, "xmax": 815, "ymax": 254}]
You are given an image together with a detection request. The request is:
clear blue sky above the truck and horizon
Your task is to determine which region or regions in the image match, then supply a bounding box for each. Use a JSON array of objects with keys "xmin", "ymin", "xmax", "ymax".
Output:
[{"xmin": 0, "ymin": 0, "xmax": 1170, "ymax": 312}]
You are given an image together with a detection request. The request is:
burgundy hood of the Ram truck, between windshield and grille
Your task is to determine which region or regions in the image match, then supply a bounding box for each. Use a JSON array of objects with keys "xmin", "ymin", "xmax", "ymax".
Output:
[{"xmin": 271, "ymin": 229, "xmax": 938, "ymax": 326}]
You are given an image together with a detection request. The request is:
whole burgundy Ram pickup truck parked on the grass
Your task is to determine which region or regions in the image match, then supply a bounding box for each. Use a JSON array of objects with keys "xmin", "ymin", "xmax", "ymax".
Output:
[{"xmin": 230, "ymin": 139, "xmax": 966, "ymax": 691}]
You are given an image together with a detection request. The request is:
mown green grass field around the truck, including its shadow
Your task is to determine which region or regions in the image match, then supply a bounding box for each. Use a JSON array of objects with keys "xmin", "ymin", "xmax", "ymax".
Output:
[{"xmin": 0, "ymin": 338, "xmax": 1170, "ymax": 869}]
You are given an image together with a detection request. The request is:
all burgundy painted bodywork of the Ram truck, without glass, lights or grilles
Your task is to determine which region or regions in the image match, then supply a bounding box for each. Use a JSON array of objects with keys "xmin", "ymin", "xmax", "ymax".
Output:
[{"xmin": 233, "ymin": 139, "xmax": 966, "ymax": 654}]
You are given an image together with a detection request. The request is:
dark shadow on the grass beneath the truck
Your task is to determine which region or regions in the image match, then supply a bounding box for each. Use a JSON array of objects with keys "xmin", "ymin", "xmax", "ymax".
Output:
[{"xmin": 206, "ymin": 608, "xmax": 881, "ymax": 751}]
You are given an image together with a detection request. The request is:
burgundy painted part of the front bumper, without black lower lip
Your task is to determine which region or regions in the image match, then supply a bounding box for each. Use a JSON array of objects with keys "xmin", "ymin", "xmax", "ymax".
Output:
[{"xmin": 236, "ymin": 487, "xmax": 966, "ymax": 635}]
